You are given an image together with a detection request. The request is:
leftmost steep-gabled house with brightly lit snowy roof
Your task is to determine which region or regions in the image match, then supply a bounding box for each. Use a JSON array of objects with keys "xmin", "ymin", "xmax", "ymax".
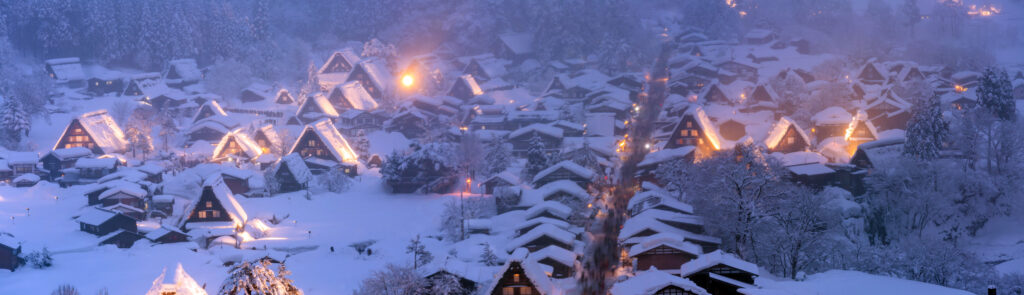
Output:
[{"xmin": 53, "ymin": 110, "xmax": 128, "ymax": 155}]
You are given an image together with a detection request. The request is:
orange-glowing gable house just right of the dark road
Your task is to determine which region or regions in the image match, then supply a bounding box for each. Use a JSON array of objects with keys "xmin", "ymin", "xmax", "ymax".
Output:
[{"xmin": 665, "ymin": 106, "xmax": 725, "ymax": 158}]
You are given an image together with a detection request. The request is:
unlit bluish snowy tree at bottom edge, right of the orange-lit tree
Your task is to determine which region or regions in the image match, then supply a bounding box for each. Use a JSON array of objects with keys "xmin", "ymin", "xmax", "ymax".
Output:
[{"xmin": 355, "ymin": 264, "xmax": 427, "ymax": 295}]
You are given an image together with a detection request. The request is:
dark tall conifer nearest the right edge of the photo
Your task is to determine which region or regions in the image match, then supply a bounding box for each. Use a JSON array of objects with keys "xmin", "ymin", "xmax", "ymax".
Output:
[{"xmin": 978, "ymin": 68, "xmax": 1017, "ymax": 121}]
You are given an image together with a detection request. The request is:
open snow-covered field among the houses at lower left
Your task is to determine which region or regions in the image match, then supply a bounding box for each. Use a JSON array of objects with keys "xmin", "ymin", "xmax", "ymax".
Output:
[{"xmin": 0, "ymin": 176, "xmax": 451, "ymax": 294}]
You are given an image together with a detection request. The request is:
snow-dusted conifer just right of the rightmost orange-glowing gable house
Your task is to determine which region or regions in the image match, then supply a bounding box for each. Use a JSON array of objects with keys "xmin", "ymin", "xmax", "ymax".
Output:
[{"xmin": 903, "ymin": 96, "xmax": 949, "ymax": 160}]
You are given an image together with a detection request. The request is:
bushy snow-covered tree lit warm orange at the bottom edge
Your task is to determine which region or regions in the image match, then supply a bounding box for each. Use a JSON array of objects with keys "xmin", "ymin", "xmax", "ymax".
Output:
[{"xmin": 217, "ymin": 258, "xmax": 302, "ymax": 295}]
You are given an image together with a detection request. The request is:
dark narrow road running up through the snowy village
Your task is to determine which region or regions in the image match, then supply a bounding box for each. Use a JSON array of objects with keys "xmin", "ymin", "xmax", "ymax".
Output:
[{"xmin": 581, "ymin": 42, "xmax": 672, "ymax": 295}]
